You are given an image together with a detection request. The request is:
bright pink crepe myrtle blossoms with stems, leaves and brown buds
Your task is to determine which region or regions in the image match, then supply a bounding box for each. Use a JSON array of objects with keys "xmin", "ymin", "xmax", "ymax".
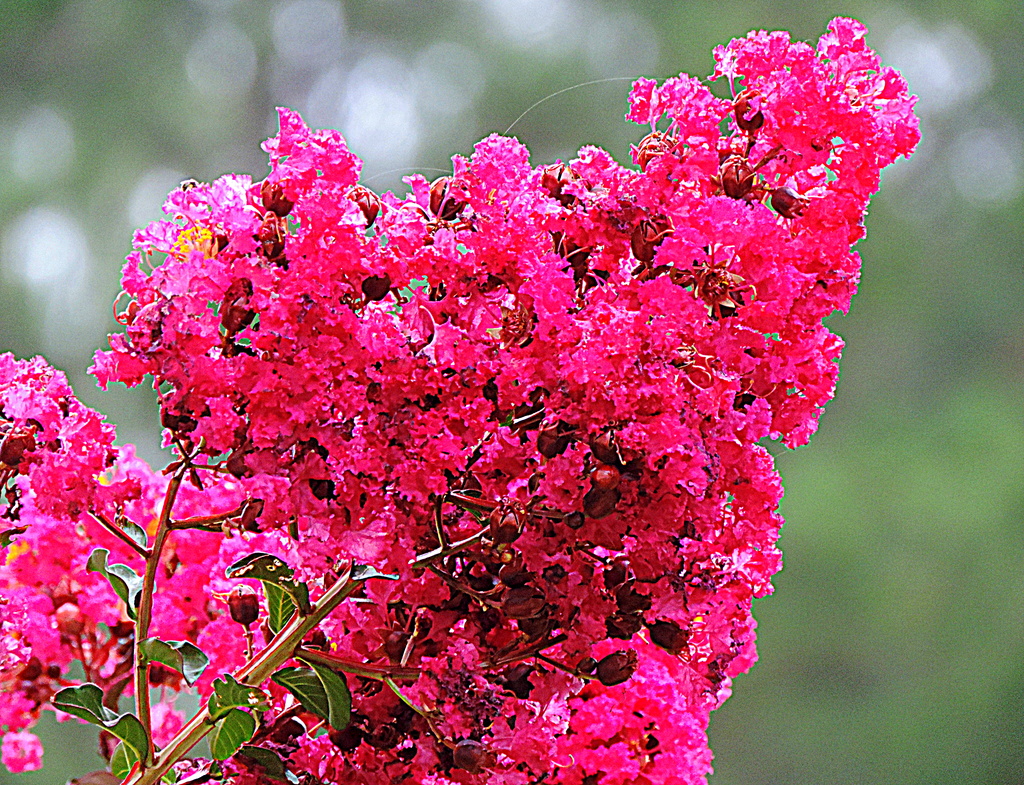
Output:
[{"xmin": 0, "ymin": 18, "xmax": 919, "ymax": 785}]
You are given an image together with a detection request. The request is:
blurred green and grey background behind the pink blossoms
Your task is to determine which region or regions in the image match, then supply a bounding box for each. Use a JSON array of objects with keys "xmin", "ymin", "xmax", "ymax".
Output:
[{"xmin": 0, "ymin": 0, "xmax": 1024, "ymax": 785}]
